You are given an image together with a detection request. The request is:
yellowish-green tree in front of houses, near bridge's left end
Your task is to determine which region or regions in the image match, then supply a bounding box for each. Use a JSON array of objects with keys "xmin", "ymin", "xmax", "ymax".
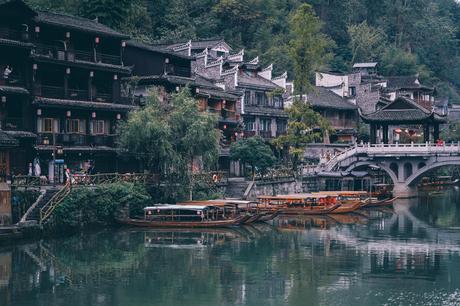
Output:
[{"xmin": 274, "ymin": 99, "xmax": 332, "ymax": 170}]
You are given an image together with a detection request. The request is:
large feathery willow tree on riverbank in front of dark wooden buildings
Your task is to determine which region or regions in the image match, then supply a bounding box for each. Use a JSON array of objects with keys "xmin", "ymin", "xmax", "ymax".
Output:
[{"xmin": 119, "ymin": 88, "xmax": 219, "ymax": 200}]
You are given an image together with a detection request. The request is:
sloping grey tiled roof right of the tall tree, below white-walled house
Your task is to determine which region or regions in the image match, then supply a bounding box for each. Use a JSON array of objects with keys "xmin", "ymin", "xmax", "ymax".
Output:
[{"xmin": 307, "ymin": 87, "xmax": 358, "ymax": 110}]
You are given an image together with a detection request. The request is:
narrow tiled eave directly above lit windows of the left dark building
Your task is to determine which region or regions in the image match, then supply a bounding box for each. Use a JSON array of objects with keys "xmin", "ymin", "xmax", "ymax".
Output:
[{"xmin": 33, "ymin": 97, "xmax": 136, "ymax": 112}]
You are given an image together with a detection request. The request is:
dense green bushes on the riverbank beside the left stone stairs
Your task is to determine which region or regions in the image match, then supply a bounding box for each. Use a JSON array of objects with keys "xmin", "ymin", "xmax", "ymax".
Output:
[{"xmin": 48, "ymin": 182, "xmax": 151, "ymax": 229}]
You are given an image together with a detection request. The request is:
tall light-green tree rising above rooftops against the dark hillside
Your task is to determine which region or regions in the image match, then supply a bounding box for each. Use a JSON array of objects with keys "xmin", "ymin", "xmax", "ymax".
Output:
[{"xmin": 289, "ymin": 4, "xmax": 333, "ymax": 95}]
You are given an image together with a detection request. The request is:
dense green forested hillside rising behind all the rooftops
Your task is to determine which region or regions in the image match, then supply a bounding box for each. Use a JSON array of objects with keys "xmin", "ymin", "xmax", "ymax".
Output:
[{"xmin": 24, "ymin": 0, "xmax": 460, "ymax": 102}]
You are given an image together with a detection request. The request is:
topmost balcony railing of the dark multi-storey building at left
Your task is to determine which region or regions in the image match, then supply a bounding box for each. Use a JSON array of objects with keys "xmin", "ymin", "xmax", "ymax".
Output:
[{"xmin": 35, "ymin": 44, "xmax": 121, "ymax": 65}]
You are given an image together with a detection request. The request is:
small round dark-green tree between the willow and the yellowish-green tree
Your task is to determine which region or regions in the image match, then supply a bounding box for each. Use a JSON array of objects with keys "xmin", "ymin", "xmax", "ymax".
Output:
[{"xmin": 230, "ymin": 136, "xmax": 275, "ymax": 177}]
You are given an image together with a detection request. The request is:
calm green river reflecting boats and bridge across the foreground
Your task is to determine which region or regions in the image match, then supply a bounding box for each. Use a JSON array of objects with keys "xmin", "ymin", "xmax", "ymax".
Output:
[{"xmin": 0, "ymin": 189, "xmax": 460, "ymax": 306}]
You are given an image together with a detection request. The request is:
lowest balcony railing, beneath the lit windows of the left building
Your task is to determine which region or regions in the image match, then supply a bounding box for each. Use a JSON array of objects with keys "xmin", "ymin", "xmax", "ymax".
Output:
[{"xmin": 38, "ymin": 133, "xmax": 116, "ymax": 147}]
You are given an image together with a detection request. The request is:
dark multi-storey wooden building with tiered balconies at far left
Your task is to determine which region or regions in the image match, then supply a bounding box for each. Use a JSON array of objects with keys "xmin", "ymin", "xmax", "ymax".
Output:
[{"xmin": 0, "ymin": 0, "xmax": 135, "ymax": 181}]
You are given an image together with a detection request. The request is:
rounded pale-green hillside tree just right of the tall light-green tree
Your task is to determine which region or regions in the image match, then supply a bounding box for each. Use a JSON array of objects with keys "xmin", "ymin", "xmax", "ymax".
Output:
[{"xmin": 348, "ymin": 21, "xmax": 386, "ymax": 63}]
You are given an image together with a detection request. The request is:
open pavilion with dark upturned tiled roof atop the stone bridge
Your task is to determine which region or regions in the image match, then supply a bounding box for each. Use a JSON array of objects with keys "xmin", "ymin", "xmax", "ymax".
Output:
[{"xmin": 360, "ymin": 96, "xmax": 447, "ymax": 143}]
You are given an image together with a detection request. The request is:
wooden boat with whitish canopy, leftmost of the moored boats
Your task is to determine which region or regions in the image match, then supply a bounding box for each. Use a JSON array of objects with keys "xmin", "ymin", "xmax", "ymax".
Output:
[{"xmin": 120, "ymin": 205, "xmax": 251, "ymax": 228}]
